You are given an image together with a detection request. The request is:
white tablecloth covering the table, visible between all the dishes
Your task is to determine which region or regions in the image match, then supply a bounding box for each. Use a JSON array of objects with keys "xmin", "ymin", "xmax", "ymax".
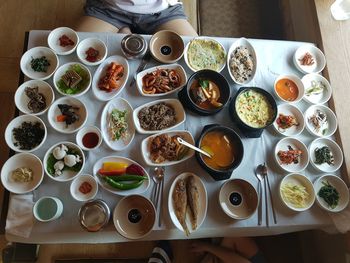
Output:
[{"xmin": 6, "ymin": 30, "xmax": 340, "ymax": 244}]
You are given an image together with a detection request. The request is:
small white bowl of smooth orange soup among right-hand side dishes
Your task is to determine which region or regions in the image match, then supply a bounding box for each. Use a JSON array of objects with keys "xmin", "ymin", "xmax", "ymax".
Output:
[{"xmin": 274, "ymin": 75, "xmax": 305, "ymax": 103}]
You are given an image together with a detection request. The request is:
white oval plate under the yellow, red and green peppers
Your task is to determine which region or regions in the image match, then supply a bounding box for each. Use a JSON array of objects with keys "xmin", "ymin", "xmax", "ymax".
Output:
[{"xmin": 93, "ymin": 156, "xmax": 151, "ymax": 196}]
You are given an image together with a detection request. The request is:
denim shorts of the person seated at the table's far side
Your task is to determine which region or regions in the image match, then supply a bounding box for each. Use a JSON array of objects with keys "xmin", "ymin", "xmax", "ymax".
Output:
[{"xmin": 85, "ymin": 0, "xmax": 187, "ymax": 34}]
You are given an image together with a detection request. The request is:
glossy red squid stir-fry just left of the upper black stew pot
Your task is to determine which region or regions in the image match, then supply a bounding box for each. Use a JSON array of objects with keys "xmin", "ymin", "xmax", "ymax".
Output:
[{"xmin": 142, "ymin": 68, "xmax": 181, "ymax": 94}]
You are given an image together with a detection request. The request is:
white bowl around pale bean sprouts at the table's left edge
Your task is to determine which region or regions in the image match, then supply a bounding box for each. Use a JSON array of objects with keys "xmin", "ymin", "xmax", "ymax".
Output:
[{"xmin": 1, "ymin": 153, "xmax": 44, "ymax": 194}]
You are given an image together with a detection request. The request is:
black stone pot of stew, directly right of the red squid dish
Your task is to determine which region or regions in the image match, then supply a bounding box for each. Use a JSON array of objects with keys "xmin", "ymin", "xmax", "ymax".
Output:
[{"xmin": 178, "ymin": 69, "xmax": 230, "ymax": 116}]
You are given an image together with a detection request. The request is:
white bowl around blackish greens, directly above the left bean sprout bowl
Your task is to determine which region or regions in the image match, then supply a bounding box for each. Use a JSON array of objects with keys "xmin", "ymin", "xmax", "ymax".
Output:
[{"xmin": 5, "ymin": 115, "xmax": 47, "ymax": 152}]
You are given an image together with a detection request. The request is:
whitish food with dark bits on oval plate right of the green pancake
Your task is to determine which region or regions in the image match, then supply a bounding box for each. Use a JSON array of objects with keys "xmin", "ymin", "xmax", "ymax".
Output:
[{"xmin": 229, "ymin": 46, "xmax": 254, "ymax": 83}]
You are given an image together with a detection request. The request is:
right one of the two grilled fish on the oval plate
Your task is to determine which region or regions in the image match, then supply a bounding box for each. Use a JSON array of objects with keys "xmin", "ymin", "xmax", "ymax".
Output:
[{"xmin": 186, "ymin": 175, "xmax": 199, "ymax": 230}]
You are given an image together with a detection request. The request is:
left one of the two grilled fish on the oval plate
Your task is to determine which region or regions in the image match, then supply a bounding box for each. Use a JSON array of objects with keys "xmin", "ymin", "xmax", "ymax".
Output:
[{"xmin": 172, "ymin": 179, "xmax": 190, "ymax": 236}]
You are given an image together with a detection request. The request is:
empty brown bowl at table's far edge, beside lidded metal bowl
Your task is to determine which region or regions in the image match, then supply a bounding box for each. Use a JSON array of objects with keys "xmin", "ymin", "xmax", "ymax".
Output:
[{"xmin": 149, "ymin": 30, "xmax": 185, "ymax": 63}]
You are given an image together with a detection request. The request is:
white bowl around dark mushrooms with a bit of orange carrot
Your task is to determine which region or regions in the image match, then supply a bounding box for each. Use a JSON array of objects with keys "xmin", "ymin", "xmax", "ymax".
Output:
[{"xmin": 47, "ymin": 97, "xmax": 88, "ymax": 133}]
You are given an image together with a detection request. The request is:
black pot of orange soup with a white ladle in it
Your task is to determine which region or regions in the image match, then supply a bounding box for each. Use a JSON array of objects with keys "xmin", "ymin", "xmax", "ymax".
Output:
[{"xmin": 196, "ymin": 124, "xmax": 244, "ymax": 181}]
